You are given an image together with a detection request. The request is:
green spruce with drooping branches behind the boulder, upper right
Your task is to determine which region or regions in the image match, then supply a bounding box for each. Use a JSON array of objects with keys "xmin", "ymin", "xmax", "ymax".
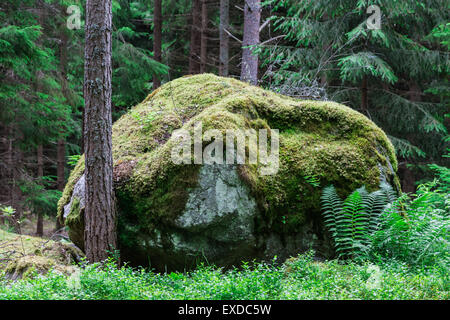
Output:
[{"xmin": 260, "ymin": 0, "xmax": 450, "ymax": 189}]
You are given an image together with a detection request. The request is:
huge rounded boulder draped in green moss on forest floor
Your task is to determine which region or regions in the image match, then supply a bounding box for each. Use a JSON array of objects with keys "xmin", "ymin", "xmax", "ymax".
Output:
[{"xmin": 58, "ymin": 74, "xmax": 398, "ymax": 270}]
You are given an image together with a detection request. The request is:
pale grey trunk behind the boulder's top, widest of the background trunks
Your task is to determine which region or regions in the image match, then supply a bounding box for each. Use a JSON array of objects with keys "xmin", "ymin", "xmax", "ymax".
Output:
[{"xmin": 241, "ymin": 0, "xmax": 261, "ymax": 85}]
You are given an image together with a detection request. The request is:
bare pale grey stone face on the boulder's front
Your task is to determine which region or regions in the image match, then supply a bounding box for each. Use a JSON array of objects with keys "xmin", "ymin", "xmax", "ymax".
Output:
[{"xmin": 175, "ymin": 164, "xmax": 257, "ymax": 242}]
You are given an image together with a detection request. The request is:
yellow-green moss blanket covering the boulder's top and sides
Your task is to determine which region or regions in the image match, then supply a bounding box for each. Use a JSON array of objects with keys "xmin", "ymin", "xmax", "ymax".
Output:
[{"xmin": 58, "ymin": 74, "xmax": 398, "ymax": 268}]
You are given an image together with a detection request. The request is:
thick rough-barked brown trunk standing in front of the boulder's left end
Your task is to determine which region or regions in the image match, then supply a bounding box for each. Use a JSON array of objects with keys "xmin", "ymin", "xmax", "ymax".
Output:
[{"xmin": 84, "ymin": 0, "xmax": 117, "ymax": 262}]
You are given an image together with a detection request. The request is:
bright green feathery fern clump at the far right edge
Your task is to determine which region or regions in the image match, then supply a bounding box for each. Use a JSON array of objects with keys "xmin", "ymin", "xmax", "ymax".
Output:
[{"xmin": 372, "ymin": 180, "xmax": 450, "ymax": 268}]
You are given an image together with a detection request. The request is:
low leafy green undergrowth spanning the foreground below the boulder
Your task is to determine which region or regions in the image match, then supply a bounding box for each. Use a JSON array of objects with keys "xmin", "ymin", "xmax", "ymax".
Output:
[{"xmin": 0, "ymin": 252, "xmax": 450, "ymax": 300}]
